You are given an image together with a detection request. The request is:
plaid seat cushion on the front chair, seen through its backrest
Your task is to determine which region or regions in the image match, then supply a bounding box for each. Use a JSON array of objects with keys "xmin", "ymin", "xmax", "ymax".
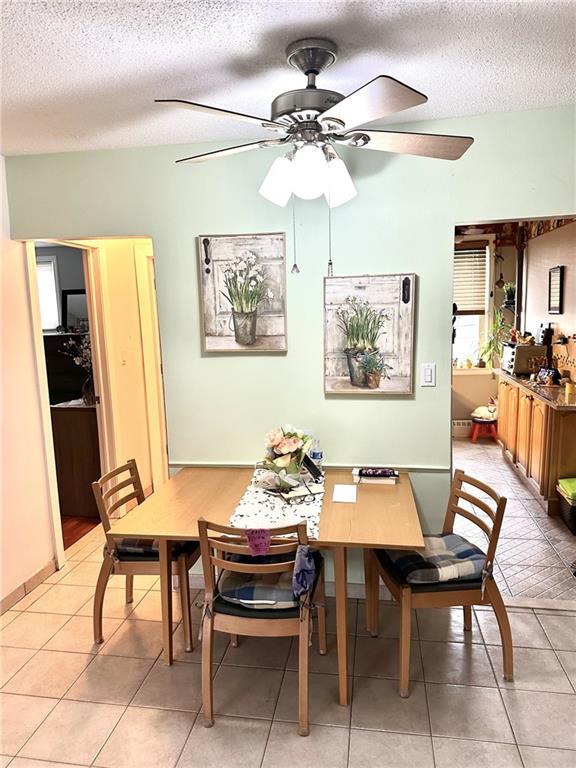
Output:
[{"xmin": 218, "ymin": 552, "xmax": 322, "ymax": 611}]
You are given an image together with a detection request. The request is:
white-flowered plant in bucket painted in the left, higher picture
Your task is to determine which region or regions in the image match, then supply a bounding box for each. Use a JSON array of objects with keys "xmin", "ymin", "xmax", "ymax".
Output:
[{"xmin": 221, "ymin": 251, "xmax": 274, "ymax": 346}]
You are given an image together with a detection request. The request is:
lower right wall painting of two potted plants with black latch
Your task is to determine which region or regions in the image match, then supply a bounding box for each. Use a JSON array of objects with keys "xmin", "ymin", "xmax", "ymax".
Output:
[{"xmin": 324, "ymin": 274, "xmax": 415, "ymax": 395}]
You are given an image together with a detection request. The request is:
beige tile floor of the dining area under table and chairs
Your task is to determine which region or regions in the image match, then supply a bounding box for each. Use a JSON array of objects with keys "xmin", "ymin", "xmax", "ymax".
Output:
[{"xmin": 0, "ymin": 520, "xmax": 576, "ymax": 768}]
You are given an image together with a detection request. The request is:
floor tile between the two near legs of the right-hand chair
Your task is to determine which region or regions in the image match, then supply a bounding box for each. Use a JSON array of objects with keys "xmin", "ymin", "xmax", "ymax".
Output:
[{"xmin": 420, "ymin": 642, "xmax": 496, "ymax": 687}]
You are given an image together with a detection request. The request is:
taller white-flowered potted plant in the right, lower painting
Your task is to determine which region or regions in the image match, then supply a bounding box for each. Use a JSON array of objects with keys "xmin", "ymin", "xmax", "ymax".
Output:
[{"xmin": 336, "ymin": 296, "xmax": 389, "ymax": 387}]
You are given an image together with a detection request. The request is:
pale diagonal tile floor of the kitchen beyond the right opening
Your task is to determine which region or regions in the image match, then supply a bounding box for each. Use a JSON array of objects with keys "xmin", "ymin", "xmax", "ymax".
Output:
[{"xmin": 453, "ymin": 440, "xmax": 576, "ymax": 608}]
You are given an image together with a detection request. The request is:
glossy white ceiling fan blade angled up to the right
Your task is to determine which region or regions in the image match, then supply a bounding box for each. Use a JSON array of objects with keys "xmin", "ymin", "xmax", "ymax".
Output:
[{"xmin": 318, "ymin": 75, "xmax": 428, "ymax": 130}]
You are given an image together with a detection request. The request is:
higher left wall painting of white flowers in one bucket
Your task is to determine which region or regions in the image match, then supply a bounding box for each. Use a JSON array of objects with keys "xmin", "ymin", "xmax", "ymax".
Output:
[{"xmin": 198, "ymin": 232, "xmax": 287, "ymax": 352}]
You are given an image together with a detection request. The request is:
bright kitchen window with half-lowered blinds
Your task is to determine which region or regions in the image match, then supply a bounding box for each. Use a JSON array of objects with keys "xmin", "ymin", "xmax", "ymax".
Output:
[{"xmin": 452, "ymin": 246, "xmax": 488, "ymax": 365}]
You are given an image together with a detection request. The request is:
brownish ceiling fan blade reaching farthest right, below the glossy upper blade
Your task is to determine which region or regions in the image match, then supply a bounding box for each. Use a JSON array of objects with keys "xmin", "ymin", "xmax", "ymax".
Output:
[{"xmin": 342, "ymin": 131, "xmax": 474, "ymax": 160}]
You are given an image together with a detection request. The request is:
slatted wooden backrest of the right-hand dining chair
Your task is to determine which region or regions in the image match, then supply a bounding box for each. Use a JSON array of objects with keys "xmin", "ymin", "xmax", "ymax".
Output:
[{"xmin": 443, "ymin": 469, "xmax": 507, "ymax": 567}]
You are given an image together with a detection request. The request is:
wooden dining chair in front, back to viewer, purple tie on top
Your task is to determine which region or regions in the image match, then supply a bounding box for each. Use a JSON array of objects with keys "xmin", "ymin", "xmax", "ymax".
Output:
[{"xmin": 198, "ymin": 519, "xmax": 326, "ymax": 736}]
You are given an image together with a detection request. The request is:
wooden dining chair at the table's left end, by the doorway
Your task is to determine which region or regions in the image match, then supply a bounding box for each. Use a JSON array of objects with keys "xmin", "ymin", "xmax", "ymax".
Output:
[{"xmin": 92, "ymin": 459, "xmax": 200, "ymax": 651}]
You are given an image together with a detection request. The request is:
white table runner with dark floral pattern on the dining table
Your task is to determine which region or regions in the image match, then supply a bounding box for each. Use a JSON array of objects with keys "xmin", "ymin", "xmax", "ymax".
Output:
[{"xmin": 230, "ymin": 469, "xmax": 324, "ymax": 539}]
